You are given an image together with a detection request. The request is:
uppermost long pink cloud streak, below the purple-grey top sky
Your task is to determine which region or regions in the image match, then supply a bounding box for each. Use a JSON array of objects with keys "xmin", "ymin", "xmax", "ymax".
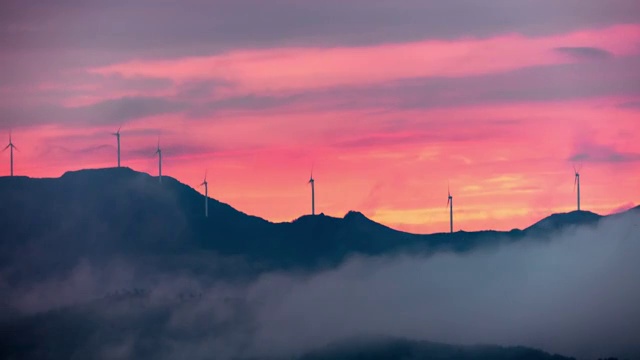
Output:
[{"xmin": 90, "ymin": 25, "xmax": 640, "ymax": 95}]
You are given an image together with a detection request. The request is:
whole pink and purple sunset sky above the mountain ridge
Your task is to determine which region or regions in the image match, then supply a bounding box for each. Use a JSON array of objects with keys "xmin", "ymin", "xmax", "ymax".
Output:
[{"xmin": 0, "ymin": 0, "xmax": 640, "ymax": 233}]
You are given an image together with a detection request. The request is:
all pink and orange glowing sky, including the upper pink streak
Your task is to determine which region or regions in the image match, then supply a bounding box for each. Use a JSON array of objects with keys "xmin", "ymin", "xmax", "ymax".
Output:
[{"xmin": 0, "ymin": 25, "xmax": 640, "ymax": 233}]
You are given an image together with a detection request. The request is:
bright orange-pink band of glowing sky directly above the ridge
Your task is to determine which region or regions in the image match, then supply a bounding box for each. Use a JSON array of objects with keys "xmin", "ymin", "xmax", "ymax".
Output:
[{"xmin": 2, "ymin": 98, "xmax": 640, "ymax": 233}]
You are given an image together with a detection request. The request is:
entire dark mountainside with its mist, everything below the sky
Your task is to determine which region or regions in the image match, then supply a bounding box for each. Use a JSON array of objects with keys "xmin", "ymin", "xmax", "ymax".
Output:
[{"xmin": 0, "ymin": 168, "xmax": 640, "ymax": 359}]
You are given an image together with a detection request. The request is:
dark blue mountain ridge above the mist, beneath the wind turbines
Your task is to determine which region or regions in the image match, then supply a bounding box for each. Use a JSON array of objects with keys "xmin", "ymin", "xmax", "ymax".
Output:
[{"xmin": 0, "ymin": 168, "xmax": 628, "ymax": 281}]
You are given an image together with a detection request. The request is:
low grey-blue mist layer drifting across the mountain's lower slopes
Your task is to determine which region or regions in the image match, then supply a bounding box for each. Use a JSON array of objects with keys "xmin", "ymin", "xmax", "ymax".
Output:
[{"xmin": 1, "ymin": 212, "xmax": 640, "ymax": 359}]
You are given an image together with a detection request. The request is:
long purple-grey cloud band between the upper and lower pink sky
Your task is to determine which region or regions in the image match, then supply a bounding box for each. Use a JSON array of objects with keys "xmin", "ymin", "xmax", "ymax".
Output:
[{"xmin": 6, "ymin": 49, "xmax": 640, "ymax": 130}]
